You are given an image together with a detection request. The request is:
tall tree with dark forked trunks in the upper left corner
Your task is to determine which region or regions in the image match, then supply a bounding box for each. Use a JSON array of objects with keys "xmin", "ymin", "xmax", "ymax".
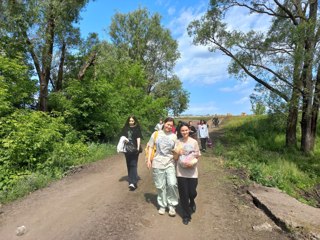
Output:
[{"xmin": 0, "ymin": 0, "xmax": 88, "ymax": 111}]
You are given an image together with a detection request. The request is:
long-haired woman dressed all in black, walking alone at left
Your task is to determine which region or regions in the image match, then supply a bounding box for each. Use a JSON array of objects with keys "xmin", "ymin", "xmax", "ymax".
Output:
[{"xmin": 121, "ymin": 115, "xmax": 142, "ymax": 191}]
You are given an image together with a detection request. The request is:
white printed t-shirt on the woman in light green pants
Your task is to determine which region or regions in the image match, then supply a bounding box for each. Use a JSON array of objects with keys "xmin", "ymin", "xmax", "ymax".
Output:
[{"xmin": 148, "ymin": 130, "xmax": 177, "ymax": 169}]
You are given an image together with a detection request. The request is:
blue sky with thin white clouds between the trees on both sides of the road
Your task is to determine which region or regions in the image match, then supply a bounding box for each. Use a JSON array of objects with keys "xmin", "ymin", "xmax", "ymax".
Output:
[{"xmin": 80, "ymin": 0, "xmax": 267, "ymax": 115}]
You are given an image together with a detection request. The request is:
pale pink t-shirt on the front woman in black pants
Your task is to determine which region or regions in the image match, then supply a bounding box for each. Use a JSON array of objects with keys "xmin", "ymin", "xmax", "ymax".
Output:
[{"xmin": 176, "ymin": 137, "xmax": 201, "ymax": 178}]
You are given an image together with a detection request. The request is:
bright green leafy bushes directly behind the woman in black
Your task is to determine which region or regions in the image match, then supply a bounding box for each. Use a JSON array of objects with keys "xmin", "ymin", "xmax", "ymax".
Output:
[{"xmin": 49, "ymin": 42, "xmax": 167, "ymax": 141}]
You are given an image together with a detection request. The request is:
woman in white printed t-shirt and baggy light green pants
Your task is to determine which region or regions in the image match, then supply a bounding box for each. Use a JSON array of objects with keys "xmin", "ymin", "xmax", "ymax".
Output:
[{"xmin": 147, "ymin": 117, "xmax": 179, "ymax": 217}]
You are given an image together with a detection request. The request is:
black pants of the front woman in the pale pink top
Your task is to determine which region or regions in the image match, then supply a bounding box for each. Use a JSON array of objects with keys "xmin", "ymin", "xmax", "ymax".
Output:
[{"xmin": 177, "ymin": 177, "xmax": 198, "ymax": 219}]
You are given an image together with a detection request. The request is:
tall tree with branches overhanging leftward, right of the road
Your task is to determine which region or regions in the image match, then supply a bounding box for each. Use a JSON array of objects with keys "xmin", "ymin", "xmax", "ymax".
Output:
[{"xmin": 188, "ymin": 0, "xmax": 320, "ymax": 152}]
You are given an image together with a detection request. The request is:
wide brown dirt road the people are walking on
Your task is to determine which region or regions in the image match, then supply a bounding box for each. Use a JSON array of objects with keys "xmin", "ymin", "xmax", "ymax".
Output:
[{"xmin": 0, "ymin": 130, "xmax": 290, "ymax": 240}]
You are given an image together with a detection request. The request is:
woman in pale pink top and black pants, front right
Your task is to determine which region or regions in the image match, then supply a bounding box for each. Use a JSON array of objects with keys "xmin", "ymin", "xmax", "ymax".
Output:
[{"xmin": 175, "ymin": 123, "xmax": 201, "ymax": 225}]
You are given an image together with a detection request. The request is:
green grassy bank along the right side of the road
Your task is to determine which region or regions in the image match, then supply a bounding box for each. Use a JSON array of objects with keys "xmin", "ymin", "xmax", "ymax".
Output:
[{"xmin": 219, "ymin": 116, "xmax": 320, "ymax": 206}]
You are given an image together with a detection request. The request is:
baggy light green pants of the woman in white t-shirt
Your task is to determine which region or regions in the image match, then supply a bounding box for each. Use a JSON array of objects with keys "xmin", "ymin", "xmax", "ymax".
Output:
[{"xmin": 152, "ymin": 166, "xmax": 179, "ymax": 208}]
